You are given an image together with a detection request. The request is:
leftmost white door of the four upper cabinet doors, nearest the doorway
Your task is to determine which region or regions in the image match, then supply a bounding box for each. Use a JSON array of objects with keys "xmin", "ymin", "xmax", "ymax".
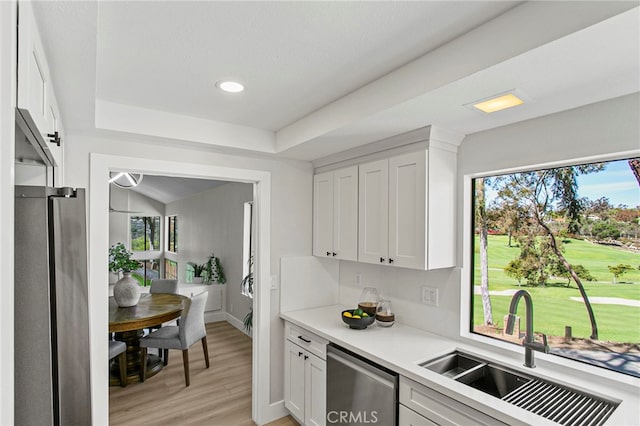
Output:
[{"xmin": 313, "ymin": 172, "xmax": 333, "ymax": 257}]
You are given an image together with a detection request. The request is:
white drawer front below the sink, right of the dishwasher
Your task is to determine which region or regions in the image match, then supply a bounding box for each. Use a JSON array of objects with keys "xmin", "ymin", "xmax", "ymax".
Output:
[{"xmin": 400, "ymin": 377, "xmax": 505, "ymax": 426}]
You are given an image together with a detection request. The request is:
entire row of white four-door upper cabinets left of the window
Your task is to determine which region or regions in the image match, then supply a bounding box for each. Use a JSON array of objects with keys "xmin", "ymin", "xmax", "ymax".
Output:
[{"xmin": 313, "ymin": 126, "xmax": 463, "ymax": 270}]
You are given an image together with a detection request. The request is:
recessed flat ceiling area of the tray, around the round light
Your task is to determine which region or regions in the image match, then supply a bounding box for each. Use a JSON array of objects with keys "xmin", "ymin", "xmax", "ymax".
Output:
[{"xmin": 96, "ymin": 2, "xmax": 516, "ymax": 130}]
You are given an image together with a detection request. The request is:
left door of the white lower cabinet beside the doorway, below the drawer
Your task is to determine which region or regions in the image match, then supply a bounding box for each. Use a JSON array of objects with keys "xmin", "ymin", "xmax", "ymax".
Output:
[{"xmin": 284, "ymin": 340, "xmax": 305, "ymax": 421}]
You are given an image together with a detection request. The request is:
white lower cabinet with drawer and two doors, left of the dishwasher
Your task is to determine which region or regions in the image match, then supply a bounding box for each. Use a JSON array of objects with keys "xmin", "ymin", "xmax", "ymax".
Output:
[{"xmin": 284, "ymin": 324, "xmax": 327, "ymax": 426}]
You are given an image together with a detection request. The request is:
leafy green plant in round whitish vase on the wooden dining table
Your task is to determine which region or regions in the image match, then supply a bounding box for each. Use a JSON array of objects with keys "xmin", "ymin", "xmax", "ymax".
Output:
[{"xmin": 109, "ymin": 243, "xmax": 140, "ymax": 308}]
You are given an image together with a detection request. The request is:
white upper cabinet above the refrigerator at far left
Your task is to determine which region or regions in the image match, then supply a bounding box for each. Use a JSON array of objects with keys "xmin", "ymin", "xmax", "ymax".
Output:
[{"xmin": 17, "ymin": 1, "xmax": 63, "ymax": 181}]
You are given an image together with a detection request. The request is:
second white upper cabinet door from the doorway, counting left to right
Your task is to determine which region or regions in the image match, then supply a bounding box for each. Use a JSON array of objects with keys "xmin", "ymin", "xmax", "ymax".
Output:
[{"xmin": 333, "ymin": 166, "xmax": 358, "ymax": 261}]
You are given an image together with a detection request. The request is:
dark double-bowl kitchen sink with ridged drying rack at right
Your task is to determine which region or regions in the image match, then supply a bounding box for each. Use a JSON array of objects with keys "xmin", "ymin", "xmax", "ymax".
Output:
[{"xmin": 420, "ymin": 351, "xmax": 620, "ymax": 426}]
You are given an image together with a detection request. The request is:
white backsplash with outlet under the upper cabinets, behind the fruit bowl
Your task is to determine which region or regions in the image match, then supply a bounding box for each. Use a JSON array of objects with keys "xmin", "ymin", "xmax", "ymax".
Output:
[{"xmin": 339, "ymin": 261, "xmax": 460, "ymax": 338}]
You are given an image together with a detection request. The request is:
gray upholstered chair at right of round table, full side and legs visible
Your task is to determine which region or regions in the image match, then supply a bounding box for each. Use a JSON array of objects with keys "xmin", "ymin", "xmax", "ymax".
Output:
[{"xmin": 140, "ymin": 291, "xmax": 209, "ymax": 386}]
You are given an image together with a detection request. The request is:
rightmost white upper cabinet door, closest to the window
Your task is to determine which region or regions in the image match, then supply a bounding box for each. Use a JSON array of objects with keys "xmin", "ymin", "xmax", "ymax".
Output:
[{"xmin": 388, "ymin": 151, "xmax": 427, "ymax": 269}]
